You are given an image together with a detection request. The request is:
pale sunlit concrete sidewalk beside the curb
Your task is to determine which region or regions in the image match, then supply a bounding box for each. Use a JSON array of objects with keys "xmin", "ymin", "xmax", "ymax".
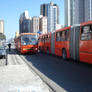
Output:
[{"xmin": 0, "ymin": 49, "xmax": 51, "ymax": 92}]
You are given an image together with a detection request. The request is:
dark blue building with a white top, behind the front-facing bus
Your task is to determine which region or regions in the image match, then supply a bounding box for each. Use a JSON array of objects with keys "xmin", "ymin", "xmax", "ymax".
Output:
[{"xmin": 19, "ymin": 11, "xmax": 32, "ymax": 33}]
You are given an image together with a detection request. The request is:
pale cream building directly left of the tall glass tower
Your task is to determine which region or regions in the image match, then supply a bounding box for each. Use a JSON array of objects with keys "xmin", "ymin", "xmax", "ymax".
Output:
[{"xmin": 39, "ymin": 16, "xmax": 47, "ymax": 34}]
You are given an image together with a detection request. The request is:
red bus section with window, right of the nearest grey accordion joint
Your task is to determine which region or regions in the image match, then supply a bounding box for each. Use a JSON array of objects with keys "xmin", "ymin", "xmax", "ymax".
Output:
[{"xmin": 80, "ymin": 25, "xmax": 92, "ymax": 64}]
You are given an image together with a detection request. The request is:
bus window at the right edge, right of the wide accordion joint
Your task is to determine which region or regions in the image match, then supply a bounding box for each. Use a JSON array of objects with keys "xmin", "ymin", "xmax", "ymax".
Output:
[{"xmin": 81, "ymin": 25, "xmax": 92, "ymax": 40}]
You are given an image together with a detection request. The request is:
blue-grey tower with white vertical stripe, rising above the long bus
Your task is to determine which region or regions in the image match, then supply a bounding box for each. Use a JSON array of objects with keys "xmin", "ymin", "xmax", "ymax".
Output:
[{"xmin": 65, "ymin": 0, "xmax": 85, "ymax": 26}]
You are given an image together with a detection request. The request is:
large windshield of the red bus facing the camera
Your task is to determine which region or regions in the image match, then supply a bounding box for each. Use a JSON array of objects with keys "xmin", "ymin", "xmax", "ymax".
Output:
[{"xmin": 21, "ymin": 35, "xmax": 38, "ymax": 45}]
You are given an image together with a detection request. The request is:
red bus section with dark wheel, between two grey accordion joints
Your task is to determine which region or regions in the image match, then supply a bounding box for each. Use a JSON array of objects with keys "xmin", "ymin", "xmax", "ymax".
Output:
[{"xmin": 55, "ymin": 27, "xmax": 71, "ymax": 59}]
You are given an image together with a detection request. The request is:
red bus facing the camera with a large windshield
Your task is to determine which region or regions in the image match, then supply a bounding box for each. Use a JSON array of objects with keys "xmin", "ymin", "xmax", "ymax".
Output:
[{"xmin": 15, "ymin": 33, "xmax": 38, "ymax": 54}]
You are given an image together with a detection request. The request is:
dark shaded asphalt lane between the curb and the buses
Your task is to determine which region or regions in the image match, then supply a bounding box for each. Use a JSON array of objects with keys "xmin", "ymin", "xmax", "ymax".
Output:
[{"xmin": 25, "ymin": 53, "xmax": 92, "ymax": 92}]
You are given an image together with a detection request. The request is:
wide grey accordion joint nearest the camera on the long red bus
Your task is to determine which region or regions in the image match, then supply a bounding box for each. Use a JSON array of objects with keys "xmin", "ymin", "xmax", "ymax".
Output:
[{"xmin": 70, "ymin": 26, "xmax": 80, "ymax": 61}]
